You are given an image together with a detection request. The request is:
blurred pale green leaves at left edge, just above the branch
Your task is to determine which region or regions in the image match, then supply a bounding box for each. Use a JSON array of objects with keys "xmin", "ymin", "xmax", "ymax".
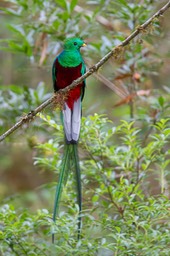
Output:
[{"xmin": 0, "ymin": 83, "xmax": 50, "ymax": 132}]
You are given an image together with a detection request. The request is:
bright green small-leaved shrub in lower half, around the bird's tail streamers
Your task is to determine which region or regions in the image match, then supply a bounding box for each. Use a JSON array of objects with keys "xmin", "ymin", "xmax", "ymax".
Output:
[{"xmin": 1, "ymin": 114, "xmax": 170, "ymax": 255}]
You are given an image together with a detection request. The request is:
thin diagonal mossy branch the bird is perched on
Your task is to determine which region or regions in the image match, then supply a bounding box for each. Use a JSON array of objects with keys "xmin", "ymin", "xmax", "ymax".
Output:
[{"xmin": 0, "ymin": 1, "xmax": 170, "ymax": 141}]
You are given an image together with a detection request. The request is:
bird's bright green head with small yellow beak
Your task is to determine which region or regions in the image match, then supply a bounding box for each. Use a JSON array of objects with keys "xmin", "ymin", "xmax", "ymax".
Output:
[{"xmin": 64, "ymin": 37, "xmax": 86, "ymax": 50}]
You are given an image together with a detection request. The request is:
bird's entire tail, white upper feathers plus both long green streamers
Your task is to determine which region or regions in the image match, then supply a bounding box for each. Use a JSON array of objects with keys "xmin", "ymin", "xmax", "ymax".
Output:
[{"xmin": 52, "ymin": 97, "xmax": 82, "ymax": 243}]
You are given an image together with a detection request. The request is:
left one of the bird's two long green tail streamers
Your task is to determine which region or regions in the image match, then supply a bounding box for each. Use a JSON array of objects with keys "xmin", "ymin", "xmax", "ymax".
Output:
[{"xmin": 52, "ymin": 145, "xmax": 70, "ymax": 243}]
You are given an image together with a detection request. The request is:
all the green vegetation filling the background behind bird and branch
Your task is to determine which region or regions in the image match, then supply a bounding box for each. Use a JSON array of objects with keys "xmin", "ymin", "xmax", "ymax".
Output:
[{"xmin": 0, "ymin": 0, "xmax": 170, "ymax": 256}]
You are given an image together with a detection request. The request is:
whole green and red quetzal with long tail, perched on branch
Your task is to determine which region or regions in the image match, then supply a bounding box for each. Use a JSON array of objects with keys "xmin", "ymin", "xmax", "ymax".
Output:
[{"xmin": 52, "ymin": 37, "xmax": 86, "ymax": 243}]
